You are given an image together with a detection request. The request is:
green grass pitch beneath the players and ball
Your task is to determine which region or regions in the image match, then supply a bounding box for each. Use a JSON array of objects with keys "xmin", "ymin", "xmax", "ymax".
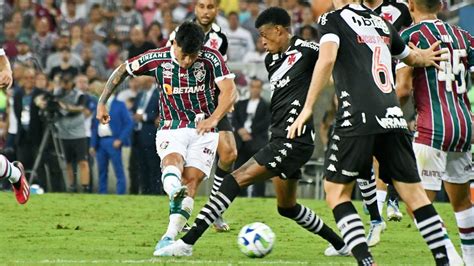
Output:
[{"xmin": 0, "ymin": 192, "xmax": 460, "ymax": 265}]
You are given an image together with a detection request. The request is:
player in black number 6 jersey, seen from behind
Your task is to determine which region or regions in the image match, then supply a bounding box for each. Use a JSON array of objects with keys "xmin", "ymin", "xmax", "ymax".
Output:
[{"xmin": 288, "ymin": 0, "xmax": 449, "ymax": 265}]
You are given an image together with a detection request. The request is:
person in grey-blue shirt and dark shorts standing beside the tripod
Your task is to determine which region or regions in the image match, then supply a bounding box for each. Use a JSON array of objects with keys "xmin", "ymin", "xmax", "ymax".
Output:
[{"xmin": 54, "ymin": 74, "xmax": 90, "ymax": 192}]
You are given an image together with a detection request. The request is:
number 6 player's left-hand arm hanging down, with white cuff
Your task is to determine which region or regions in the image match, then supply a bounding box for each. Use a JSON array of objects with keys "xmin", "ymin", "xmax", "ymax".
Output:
[{"xmin": 287, "ymin": 40, "xmax": 339, "ymax": 139}]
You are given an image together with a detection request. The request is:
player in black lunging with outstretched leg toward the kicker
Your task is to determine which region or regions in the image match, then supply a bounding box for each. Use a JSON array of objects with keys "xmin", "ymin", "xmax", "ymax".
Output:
[{"xmin": 154, "ymin": 7, "xmax": 349, "ymax": 256}]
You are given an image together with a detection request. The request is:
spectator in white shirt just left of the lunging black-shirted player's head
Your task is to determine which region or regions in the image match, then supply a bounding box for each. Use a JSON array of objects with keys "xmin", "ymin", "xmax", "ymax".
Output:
[{"xmin": 227, "ymin": 12, "xmax": 255, "ymax": 62}]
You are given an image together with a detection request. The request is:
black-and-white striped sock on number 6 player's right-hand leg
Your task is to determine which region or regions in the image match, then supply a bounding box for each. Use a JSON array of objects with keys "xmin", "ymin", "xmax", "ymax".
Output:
[{"xmin": 413, "ymin": 204, "xmax": 449, "ymax": 265}]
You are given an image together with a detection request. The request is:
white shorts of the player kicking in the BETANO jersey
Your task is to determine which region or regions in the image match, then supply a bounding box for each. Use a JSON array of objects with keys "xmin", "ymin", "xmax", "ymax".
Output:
[{"xmin": 155, "ymin": 128, "xmax": 219, "ymax": 177}]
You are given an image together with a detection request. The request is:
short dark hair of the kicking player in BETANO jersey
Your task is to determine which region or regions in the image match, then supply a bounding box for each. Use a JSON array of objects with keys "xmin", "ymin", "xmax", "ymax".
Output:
[{"xmin": 175, "ymin": 21, "xmax": 204, "ymax": 54}]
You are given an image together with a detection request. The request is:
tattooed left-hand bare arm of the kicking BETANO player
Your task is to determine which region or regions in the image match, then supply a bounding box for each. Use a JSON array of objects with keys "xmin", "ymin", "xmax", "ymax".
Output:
[{"xmin": 96, "ymin": 63, "xmax": 130, "ymax": 124}]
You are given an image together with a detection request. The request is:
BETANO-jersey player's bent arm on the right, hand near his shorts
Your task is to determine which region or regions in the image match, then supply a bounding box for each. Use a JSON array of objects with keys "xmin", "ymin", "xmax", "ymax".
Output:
[{"xmin": 197, "ymin": 78, "xmax": 237, "ymax": 134}]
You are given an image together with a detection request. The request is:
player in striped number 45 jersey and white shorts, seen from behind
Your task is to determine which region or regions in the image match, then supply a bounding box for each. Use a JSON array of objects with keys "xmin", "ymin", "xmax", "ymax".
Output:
[{"xmin": 397, "ymin": 0, "xmax": 474, "ymax": 265}]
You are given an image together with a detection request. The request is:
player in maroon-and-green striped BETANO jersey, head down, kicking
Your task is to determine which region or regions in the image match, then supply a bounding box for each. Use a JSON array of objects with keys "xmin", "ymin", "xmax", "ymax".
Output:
[{"xmin": 97, "ymin": 22, "xmax": 236, "ymax": 251}]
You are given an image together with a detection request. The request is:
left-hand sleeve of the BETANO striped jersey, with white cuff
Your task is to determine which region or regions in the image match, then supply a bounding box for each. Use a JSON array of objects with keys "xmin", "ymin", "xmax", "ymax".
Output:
[{"xmin": 125, "ymin": 49, "xmax": 164, "ymax": 77}]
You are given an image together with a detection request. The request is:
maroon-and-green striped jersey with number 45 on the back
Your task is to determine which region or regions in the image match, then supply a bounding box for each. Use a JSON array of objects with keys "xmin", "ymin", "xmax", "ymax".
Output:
[{"xmin": 401, "ymin": 19, "xmax": 474, "ymax": 152}]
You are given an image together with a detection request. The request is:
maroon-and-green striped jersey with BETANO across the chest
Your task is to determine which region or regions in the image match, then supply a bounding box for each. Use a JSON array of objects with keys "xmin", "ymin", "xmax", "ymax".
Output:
[{"xmin": 126, "ymin": 47, "xmax": 234, "ymax": 130}]
